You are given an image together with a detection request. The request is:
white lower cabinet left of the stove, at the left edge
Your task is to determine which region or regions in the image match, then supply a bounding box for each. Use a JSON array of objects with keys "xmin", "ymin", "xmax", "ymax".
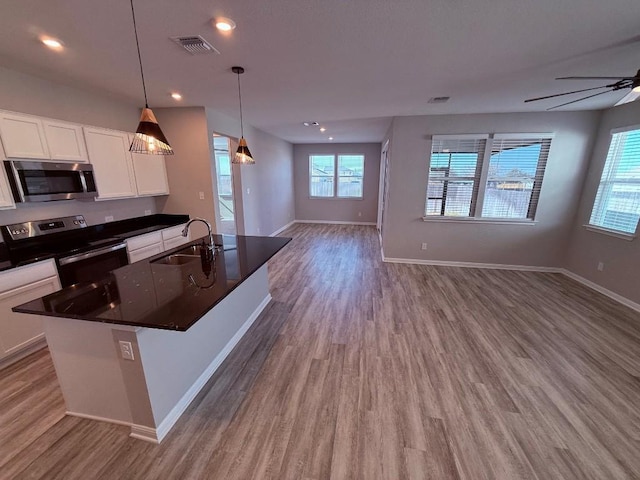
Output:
[{"xmin": 0, "ymin": 260, "xmax": 60, "ymax": 366}]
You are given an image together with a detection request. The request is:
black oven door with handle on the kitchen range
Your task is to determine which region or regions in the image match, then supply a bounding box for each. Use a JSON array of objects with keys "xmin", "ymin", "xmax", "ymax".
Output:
[{"xmin": 58, "ymin": 243, "xmax": 129, "ymax": 287}]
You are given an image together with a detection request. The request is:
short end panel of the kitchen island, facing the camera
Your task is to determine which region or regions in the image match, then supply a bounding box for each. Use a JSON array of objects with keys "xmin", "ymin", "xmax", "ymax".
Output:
[{"xmin": 43, "ymin": 317, "xmax": 131, "ymax": 425}]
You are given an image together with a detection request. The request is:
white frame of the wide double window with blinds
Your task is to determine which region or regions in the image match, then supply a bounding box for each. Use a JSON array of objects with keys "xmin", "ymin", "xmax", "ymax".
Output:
[{"xmin": 422, "ymin": 132, "xmax": 554, "ymax": 221}]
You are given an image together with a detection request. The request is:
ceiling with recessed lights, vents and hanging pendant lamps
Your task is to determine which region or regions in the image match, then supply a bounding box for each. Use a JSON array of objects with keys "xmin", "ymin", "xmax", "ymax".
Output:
[{"xmin": 0, "ymin": 0, "xmax": 640, "ymax": 143}]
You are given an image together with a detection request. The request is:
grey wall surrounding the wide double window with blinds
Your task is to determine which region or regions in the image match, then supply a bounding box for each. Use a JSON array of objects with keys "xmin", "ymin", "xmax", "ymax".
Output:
[{"xmin": 383, "ymin": 112, "xmax": 600, "ymax": 266}]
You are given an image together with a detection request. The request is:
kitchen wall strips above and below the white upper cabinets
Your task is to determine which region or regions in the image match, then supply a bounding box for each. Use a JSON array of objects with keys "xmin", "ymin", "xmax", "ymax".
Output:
[{"xmin": 0, "ymin": 68, "xmax": 156, "ymax": 229}]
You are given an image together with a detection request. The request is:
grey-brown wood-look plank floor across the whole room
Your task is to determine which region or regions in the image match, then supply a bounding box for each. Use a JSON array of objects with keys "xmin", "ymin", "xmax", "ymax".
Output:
[{"xmin": 0, "ymin": 225, "xmax": 640, "ymax": 480}]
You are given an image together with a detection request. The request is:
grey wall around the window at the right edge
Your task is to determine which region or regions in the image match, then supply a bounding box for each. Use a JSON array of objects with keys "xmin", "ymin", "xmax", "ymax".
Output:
[{"xmin": 563, "ymin": 102, "xmax": 640, "ymax": 303}]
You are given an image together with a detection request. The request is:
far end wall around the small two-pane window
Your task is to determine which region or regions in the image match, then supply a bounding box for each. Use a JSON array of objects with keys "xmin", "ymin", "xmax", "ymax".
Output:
[{"xmin": 293, "ymin": 143, "xmax": 381, "ymax": 223}]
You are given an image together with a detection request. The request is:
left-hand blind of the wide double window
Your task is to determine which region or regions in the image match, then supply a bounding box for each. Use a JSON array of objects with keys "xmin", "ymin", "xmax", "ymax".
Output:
[{"xmin": 425, "ymin": 136, "xmax": 487, "ymax": 217}]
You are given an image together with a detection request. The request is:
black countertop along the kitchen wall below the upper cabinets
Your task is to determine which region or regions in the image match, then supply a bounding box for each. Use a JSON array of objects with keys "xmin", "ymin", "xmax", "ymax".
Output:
[{"xmin": 0, "ymin": 213, "xmax": 189, "ymax": 271}]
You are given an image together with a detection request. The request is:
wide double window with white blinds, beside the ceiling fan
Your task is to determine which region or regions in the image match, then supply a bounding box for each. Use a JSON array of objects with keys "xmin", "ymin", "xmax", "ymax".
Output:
[{"xmin": 425, "ymin": 134, "xmax": 551, "ymax": 220}]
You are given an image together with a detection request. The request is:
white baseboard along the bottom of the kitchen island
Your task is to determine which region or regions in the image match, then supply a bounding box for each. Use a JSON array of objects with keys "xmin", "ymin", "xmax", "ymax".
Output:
[{"xmin": 149, "ymin": 294, "xmax": 271, "ymax": 443}]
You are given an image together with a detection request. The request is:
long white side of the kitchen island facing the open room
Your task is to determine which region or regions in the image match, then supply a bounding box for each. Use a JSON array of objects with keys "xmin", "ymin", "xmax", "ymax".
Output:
[{"xmin": 132, "ymin": 265, "xmax": 271, "ymax": 441}]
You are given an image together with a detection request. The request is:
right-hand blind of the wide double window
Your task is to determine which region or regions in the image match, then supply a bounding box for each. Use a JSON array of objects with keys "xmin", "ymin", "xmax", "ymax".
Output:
[{"xmin": 482, "ymin": 134, "xmax": 551, "ymax": 219}]
